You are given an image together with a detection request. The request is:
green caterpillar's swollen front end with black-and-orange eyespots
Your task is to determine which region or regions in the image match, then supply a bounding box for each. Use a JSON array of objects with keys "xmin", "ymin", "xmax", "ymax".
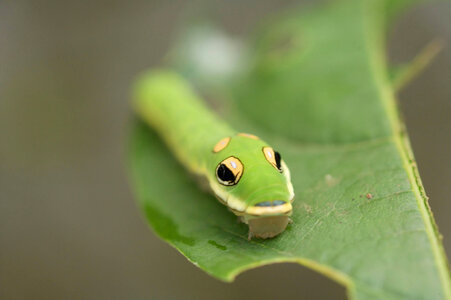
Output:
[{"xmin": 209, "ymin": 134, "xmax": 294, "ymax": 237}]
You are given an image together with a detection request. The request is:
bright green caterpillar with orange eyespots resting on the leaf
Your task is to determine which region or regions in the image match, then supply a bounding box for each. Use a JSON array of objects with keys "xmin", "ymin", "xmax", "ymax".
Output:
[{"xmin": 133, "ymin": 70, "xmax": 294, "ymax": 239}]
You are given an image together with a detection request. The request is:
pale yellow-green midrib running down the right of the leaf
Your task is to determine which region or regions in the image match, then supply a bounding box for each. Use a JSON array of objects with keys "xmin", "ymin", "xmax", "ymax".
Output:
[{"xmin": 364, "ymin": 1, "xmax": 451, "ymax": 299}]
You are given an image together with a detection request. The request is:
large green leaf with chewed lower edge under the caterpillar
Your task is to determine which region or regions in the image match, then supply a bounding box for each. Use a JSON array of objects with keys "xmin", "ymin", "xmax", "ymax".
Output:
[{"xmin": 130, "ymin": 0, "xmax": 451, "ymax": 299}]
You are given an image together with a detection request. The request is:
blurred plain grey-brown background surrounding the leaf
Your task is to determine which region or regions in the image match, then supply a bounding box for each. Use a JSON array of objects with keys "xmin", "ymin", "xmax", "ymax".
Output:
[{"xmin": 0, "ymin": 0, "xmax": 451, "ymax": 299}]
